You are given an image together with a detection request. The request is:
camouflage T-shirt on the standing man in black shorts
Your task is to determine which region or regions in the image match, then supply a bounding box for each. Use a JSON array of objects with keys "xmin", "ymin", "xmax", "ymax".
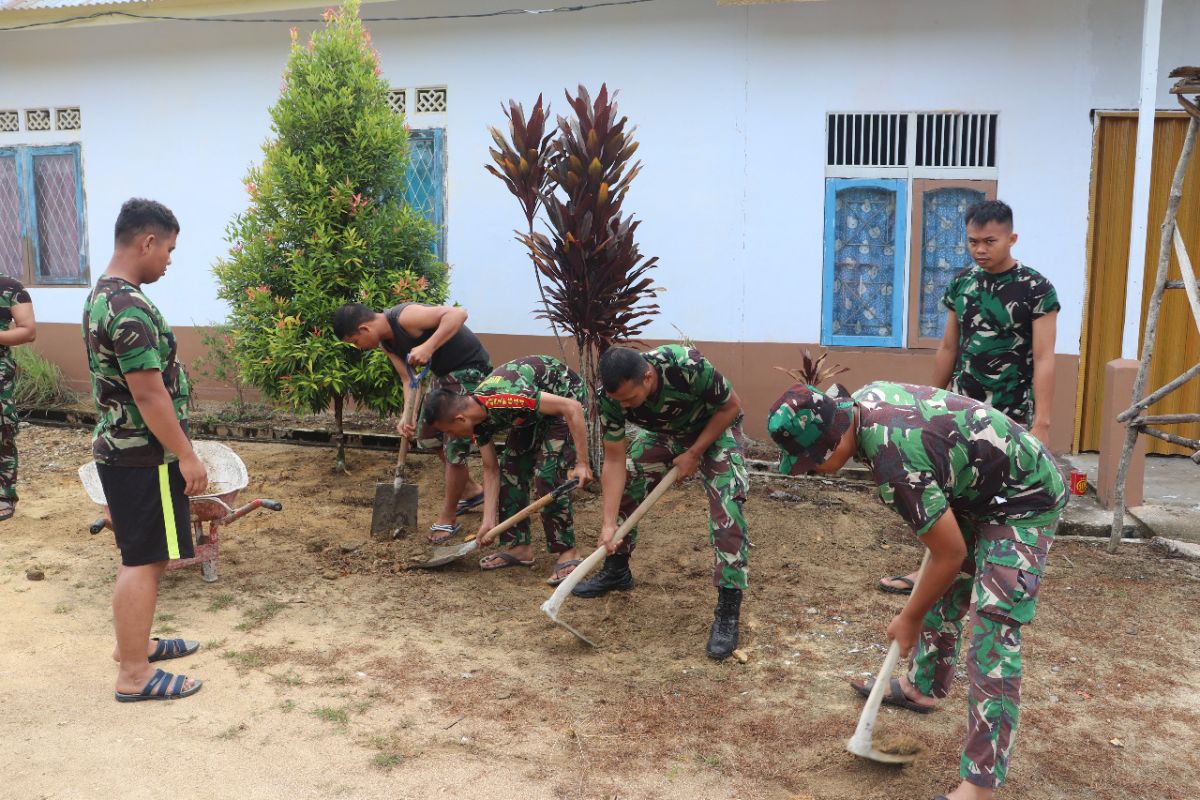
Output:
[{"xmin": 83, "ymin": 275, "xmax": 188, "ymax": 467}]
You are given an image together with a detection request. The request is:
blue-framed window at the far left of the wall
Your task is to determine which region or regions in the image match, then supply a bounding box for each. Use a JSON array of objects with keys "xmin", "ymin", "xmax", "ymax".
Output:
[{"xmin": 0, "ymin": 144, "xmax": 89, "ymax": 285}]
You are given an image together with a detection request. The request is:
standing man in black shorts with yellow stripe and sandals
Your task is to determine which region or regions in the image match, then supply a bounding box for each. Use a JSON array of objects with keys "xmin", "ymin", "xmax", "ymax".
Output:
[{"xmin": 83, "ymin": 199, "xmax": 208, "ymax": 703}]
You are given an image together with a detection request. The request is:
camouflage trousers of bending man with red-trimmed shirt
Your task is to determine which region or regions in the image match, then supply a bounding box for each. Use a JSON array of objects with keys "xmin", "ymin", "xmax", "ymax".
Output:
[{"xmin": 499, "ymin": 416, "xmax": 576, "ymax": 553}]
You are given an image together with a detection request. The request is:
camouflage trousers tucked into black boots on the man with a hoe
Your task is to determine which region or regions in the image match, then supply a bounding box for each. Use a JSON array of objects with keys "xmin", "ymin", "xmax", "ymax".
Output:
[{"xmin": 617, "ymin": 421, "xmax": 750, "ymax": 589}]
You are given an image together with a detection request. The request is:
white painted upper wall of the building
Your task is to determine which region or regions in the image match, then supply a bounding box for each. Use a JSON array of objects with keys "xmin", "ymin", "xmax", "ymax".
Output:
[{"xmin": 0, "ymin": 0, "xmax": 1200, "ymax": 353}]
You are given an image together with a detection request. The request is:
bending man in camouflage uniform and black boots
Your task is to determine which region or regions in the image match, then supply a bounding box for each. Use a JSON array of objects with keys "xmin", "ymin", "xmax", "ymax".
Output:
[{"xmin": 574, "ymin": 344, "xmax": 749, "ymax": 658}]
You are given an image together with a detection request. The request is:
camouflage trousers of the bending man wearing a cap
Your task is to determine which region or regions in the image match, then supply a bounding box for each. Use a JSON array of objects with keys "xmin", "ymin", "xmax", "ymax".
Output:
[{"xmin": 908, "ymin": 510, "xmax": 1058, "ymax": 788}]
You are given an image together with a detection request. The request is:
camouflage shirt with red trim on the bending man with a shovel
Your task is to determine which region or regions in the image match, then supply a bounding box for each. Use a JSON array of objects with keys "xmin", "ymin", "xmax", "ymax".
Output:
[{"xmin": 472, "ymin": 355, "xmax": 587, "ymax": 445}]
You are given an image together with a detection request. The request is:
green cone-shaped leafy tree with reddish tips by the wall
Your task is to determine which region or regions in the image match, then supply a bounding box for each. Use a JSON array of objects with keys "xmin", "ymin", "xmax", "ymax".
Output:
[{"xmin": 214, "ymin": 0, "xmax": 448, "ymax": 470}]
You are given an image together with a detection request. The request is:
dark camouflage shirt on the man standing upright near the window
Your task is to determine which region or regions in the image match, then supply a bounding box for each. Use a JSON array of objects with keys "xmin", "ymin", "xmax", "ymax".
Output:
[{"xmin": 942, "ymin": 264, "xmax": 1060, "ymax": 425}]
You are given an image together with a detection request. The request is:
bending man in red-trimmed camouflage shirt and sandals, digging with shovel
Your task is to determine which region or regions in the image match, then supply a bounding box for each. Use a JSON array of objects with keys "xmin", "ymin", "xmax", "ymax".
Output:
[{"xmin": 424, "ymin": 355, "xmax": 592, "ymax": 585}]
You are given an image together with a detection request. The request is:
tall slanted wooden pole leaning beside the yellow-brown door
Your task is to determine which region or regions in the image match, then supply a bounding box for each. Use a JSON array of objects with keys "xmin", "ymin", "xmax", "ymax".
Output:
[{"xmin": 1108, "ymin": 116, "xmax": 1200, "ymax": 553}]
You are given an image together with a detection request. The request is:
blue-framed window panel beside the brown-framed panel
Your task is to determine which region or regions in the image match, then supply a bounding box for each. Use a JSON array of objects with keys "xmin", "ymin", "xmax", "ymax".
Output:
[{"xmin": 821, "ymin": 179, "xmax": 908, "ymax": 347}]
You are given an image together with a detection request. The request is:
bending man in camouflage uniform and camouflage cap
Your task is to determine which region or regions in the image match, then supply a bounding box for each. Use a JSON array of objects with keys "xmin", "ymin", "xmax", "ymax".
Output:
[{"xmin": 768, "ymin": 381, "xmax": 1067, "ymax": 800}]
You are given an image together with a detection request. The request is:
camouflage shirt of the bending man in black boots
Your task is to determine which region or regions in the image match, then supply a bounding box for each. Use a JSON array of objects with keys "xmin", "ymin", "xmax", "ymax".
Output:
[{"xmin": 600, "ymin": 344, "xmax": 733, "ymax": 441}]
